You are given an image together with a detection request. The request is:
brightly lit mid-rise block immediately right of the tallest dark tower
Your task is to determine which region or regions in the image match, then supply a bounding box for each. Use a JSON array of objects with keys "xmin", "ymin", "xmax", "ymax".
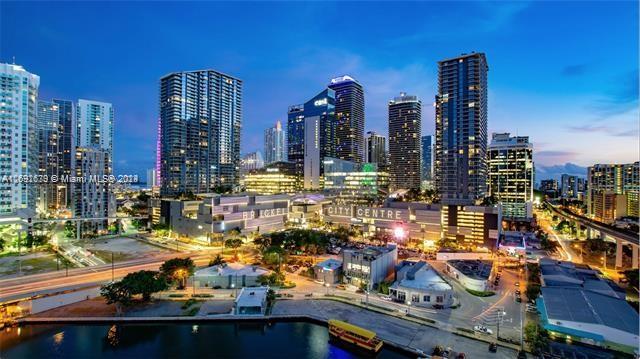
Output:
[{"xmin": 489, "ymin": 133, "xmax": 534, "ymax": 220}]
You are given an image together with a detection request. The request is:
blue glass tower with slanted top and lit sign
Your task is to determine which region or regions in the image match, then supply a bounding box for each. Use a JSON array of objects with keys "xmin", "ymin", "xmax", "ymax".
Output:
[{"xmin": 287, "ymin": 89, "xmax": 336, "ymax": 189}]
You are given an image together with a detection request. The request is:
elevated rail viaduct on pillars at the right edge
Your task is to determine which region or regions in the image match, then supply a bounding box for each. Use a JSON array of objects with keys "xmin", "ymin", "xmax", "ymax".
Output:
[{"xmin": 545, "ymin": 202, "xmax": 640, "ymax": 268}]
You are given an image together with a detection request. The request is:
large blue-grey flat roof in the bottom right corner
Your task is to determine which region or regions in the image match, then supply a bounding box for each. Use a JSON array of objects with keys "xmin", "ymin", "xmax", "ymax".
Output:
[{"xmin": 542, "ymin": 287, "xmax": 639, "ymax": 335}]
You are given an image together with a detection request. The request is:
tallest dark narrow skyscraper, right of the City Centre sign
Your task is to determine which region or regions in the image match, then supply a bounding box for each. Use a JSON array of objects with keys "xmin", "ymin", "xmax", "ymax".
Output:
[{"xmin": 435, "ymin": 53, "xmax": 489, "ymax": 205}]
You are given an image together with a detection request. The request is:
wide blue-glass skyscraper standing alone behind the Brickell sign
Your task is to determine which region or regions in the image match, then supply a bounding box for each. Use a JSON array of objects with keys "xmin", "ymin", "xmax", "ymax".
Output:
[{"xmin": 160, "ymin": 70, "xmax": 243, "ymax": 195}]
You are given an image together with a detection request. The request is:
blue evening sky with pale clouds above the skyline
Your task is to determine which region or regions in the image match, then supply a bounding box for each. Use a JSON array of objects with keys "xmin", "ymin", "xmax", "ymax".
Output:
[{"xmin": 0, "ymin": 1, "xmax": 639, "ymax": 180}]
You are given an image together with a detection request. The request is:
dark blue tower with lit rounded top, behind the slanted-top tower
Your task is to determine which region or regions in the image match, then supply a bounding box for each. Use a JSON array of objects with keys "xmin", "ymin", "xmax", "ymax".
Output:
[{"xmin": 329, "ymin": 75, "xmax": 364, "ymax": 162}]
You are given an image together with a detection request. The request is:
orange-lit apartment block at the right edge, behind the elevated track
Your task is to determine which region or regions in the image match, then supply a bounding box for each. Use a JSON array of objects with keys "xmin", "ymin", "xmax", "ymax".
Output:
[{"xmin": 587, "ymin": 162, "xmax": 640, "ymax": 223}]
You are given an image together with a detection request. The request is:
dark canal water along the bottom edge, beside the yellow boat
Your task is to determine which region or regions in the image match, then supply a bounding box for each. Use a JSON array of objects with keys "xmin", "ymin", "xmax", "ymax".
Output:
[{"xmin": 0, "ymin": 322, "xmax": 406, "ymax": 359}]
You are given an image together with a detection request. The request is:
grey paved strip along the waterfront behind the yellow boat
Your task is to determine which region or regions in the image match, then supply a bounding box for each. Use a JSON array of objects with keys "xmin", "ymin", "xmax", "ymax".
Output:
[{"xmin": 272, "ymin": 300, "xmax": 517, "ymax": 358}]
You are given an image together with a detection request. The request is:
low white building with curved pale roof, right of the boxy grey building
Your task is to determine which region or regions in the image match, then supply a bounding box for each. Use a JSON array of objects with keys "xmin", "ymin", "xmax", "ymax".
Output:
[{"xmin": 389, "ymin": 261, "xmax": 454, "ymax": 307}]
